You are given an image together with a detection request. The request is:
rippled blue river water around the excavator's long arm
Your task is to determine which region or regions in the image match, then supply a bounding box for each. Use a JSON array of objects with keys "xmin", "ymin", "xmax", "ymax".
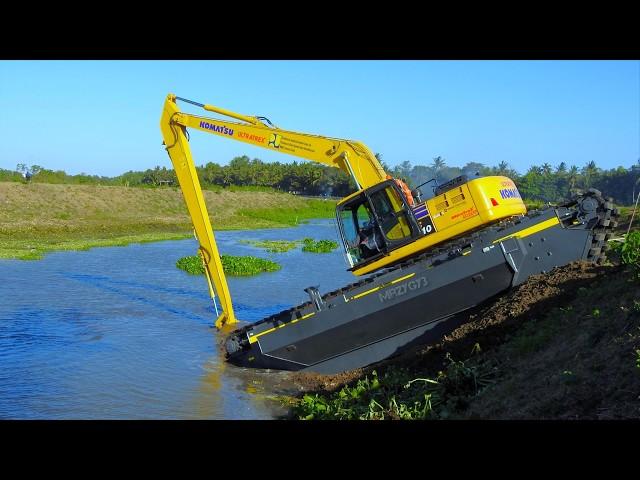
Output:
[{"xmin": 0, "ymin": 220, "xmax": 355, "ymax": 419}]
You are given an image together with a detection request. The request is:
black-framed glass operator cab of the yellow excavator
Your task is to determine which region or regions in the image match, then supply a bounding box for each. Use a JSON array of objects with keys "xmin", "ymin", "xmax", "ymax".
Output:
[{"xmin": 336, "ymin": 180, "xmax": 422, "ymax": 270}]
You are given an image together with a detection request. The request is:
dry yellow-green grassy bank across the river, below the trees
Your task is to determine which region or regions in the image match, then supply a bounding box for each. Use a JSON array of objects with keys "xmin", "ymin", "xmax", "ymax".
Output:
[{"xmin": 0, "ymin": 182, "xmax": 335, "ymax": 259}]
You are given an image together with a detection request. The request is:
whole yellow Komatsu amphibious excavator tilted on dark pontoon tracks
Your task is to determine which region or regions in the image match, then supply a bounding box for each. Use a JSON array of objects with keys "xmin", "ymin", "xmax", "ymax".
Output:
[{"xmin": 160, "ymin": 94, "xmax": 617, "ymax": 373}]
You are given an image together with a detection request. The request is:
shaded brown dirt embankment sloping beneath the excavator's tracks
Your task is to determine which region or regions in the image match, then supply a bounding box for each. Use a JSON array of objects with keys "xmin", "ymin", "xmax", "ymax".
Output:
[{"xmin": 292, "ymin": 262, "xmax": 640, "ymax": 419}]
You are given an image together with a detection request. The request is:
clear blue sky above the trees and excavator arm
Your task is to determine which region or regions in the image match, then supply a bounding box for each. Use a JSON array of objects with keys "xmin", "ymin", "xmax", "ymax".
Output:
[{"xmin": 0, "ymin": 60, "xmax": 640, "ymax": 176}]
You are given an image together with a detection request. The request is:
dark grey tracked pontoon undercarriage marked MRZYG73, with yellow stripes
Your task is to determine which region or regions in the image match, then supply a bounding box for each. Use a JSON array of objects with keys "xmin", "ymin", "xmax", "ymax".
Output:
[{"xmin": 225, "ymin": 189, "xmax": 617, "ymax": 373}]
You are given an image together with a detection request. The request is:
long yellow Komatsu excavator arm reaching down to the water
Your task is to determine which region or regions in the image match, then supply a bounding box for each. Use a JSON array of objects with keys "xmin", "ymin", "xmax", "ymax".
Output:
[{"xmin": 160, "ymin": 94, "xmax": 390, "ymax": 328}]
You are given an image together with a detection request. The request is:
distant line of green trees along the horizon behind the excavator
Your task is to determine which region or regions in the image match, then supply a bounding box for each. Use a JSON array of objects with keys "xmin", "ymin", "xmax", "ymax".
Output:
[{"xmin": 0, "ymin": 154, "xmax": 640, "ymax": 205}]
